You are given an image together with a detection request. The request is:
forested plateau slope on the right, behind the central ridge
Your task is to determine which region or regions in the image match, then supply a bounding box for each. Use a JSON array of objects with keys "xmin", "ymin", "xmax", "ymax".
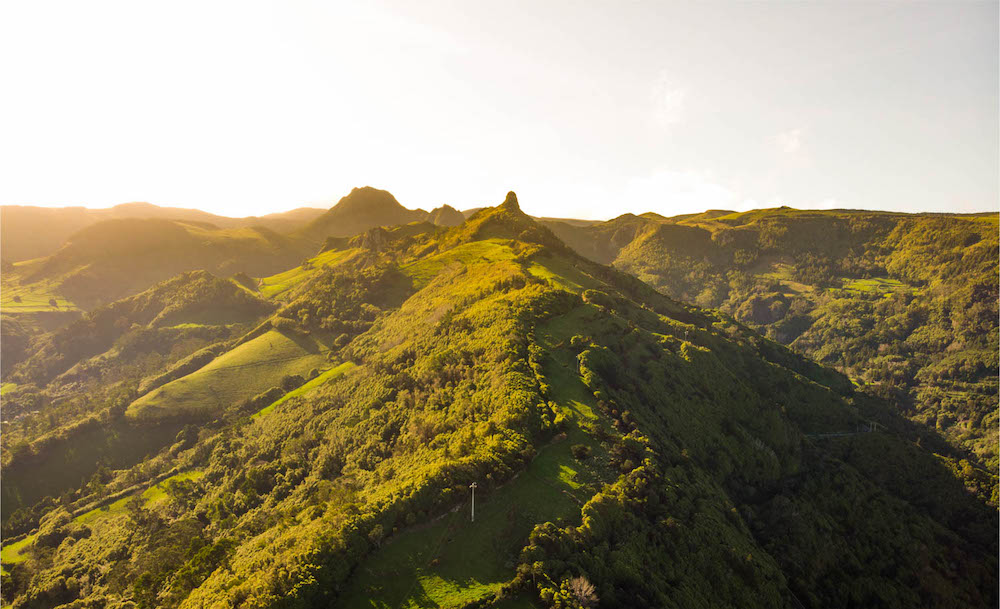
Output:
[{"xmin": 548, "ymin": 208, "xmax": 1000, "ymax": 494}]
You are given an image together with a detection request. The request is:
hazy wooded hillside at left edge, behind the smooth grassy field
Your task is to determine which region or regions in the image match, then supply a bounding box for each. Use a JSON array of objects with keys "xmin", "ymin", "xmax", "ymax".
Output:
[{"xmin": 0, "ymin": 271, "xmax": 274, "ymax": 527}]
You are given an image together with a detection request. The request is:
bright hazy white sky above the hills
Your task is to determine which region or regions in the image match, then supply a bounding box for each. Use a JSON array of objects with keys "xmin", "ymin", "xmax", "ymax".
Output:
[{"xmin": 0, "ymin": 0, "xmax": 1000, "ymax": 219}]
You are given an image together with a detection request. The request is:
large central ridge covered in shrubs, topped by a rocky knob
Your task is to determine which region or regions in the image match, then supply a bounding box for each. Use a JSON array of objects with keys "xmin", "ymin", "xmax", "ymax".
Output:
[{"xmin": 2, "ymin": 193, "xmax": 997, "ymax": 607}]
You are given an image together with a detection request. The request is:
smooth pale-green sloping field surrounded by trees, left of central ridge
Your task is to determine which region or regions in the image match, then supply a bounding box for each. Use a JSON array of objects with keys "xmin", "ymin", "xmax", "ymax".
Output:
[{"xmin": 126, "ymin": 330, "xmax": 328, "ymax": 420}]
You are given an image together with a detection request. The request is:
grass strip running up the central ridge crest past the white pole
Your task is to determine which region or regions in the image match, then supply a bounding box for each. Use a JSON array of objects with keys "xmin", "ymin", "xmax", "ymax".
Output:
[{"xmin": 339, "ymin": 264, "xmax": 613, "ymax": 608}]
